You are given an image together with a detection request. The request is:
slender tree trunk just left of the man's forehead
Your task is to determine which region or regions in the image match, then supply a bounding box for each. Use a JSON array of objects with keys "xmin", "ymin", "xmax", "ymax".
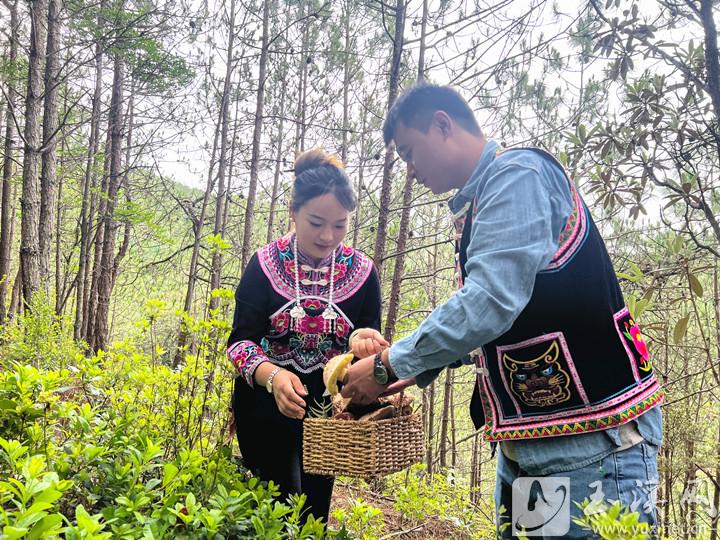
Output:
[{"xmin": 373, "ymin": 0, "xmax": 405, "ymax": 278}]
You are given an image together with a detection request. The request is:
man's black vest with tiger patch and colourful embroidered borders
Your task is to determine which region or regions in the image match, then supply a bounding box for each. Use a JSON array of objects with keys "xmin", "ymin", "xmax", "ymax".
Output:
[{"xmin": 456, "ymin": 149, "xmax": 663, "ymax": 441}]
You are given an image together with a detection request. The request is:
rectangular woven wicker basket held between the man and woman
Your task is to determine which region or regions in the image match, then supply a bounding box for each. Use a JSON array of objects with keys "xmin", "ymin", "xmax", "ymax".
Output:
[{"xmin": 303, "ymin": 413, "xmax": 423, "ymax": 478}]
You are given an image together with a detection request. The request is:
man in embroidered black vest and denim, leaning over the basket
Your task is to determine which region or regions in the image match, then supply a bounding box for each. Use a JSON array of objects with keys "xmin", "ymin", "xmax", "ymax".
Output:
[{"xmin": 342, "ymin": 84, "xmax": 662, "ymax": 538}]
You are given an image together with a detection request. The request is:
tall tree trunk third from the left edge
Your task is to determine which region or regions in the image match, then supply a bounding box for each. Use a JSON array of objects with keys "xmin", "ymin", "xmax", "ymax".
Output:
[{"xmin": 39, "ymin": 0, "xmax": 62, "ymax": 286}]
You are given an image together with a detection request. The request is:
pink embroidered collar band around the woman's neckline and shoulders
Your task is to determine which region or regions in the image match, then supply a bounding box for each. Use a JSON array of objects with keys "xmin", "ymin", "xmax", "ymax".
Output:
[{"xmin": 258, "ymin": 234, "xmax": 372, "ymax": 303}]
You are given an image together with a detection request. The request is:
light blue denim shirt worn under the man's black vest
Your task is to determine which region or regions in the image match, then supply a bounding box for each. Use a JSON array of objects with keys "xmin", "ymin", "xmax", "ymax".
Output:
[{"xmin": 389, "ymin": 141, "xmax": 662, "ymax": 475}]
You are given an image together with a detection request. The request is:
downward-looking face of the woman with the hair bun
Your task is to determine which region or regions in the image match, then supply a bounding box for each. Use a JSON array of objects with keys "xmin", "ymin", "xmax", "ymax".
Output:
[{"xmin": 290, "ymin": 193, "xmax": 350, "ymax": 262}]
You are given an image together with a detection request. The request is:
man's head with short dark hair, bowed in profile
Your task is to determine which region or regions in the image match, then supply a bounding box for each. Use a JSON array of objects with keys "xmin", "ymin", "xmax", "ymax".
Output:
[{"xmin": 383, "ymin": 83, "xmax": 484, "ymax": 193}]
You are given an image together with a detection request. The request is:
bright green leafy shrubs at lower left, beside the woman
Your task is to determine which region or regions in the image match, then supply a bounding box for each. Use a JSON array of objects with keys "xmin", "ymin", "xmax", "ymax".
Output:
[{"xmin": 0, "ymin": 303, "xmax": 325, "ymax": 540}]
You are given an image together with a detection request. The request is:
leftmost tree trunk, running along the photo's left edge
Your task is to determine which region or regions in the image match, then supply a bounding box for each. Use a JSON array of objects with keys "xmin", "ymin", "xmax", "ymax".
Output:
[{"xmin": 0, "ymin": 0, "xmax": 19, "ymax": 324}]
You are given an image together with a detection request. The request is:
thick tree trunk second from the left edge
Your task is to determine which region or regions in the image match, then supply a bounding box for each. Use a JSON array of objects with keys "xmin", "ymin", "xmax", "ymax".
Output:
[{"xmin": 20, "ymin": 0, "xmax": 48, "ymax": 305}]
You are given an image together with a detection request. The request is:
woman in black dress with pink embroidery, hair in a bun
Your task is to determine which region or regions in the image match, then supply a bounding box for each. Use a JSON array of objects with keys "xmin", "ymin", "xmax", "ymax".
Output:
[{"xmin": 228, "ymin": 149, "xmax": 387, "ymax": 521}]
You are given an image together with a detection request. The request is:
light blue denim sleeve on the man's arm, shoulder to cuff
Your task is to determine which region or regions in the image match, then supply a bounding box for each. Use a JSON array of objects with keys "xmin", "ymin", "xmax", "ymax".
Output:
[{"xmin": 389, "ymin": 156, "xmax": 572, "ymax": 387}]
